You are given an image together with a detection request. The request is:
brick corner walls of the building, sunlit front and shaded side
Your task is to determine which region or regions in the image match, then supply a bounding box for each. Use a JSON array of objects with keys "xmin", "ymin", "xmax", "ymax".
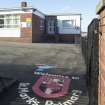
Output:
[{"xmin": 21, "ymin": 13, "xmax": 44, "ymax": 43}]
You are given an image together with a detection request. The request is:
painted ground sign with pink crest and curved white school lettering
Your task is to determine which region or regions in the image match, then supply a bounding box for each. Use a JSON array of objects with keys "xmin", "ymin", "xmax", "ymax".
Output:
[{"xmin": 18, "ymin": 75, "xmax": 82, "ymax": 105}]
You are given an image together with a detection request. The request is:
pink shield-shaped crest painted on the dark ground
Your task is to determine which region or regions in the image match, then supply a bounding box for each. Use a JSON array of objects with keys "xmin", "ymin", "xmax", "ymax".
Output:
[{"xmin": 32, "ymin": 75, "xmax": 70, "ymax": 99}]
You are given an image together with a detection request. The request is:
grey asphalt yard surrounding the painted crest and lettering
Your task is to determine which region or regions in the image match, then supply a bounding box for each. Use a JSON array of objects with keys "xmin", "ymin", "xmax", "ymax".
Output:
[{"xmin": 0, "ymin": 42, "xmax": 88, "ymax": 105}]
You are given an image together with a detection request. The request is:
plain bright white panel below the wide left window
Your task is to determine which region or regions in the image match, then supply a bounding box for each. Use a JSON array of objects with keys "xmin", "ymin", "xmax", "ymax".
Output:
[{"xmin": 0, "ymin": 28, "xmax": 21, "ymax": 37}]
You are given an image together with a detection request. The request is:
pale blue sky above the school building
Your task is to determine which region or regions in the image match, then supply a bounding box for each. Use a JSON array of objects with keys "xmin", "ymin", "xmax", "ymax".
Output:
[{"xmin": 0, "ymin": 0, "xmax": 99, "ymax": 31}]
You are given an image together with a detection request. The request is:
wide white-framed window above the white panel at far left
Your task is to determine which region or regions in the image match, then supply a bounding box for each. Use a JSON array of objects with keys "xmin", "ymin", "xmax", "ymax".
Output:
[{"xmin": 0, "ymin": 14, "xmax": 20, "ymax": 28}]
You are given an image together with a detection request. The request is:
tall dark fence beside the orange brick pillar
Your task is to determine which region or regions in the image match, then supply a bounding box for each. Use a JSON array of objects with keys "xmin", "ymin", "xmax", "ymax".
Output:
[{"xmin": 82, "ymin": 19, "xmax": 99, "ymax": 105}]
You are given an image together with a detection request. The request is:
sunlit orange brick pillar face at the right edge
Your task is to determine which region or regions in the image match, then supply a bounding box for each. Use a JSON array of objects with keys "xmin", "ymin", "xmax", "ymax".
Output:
[{"xmin": 99, "ymin": 9, "xmax": 105, "ymax": 105}]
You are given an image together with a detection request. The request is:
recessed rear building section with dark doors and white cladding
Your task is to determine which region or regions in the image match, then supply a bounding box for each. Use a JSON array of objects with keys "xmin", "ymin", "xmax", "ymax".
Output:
[{"xmin": 45, "ymin": 13, "xmax": 81, "ymax": 43}]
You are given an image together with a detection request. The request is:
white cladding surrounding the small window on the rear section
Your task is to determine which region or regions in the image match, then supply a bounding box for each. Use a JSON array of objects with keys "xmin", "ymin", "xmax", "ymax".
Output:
[{"xmin": 57, "ymin": 15, "xmax": 81, "ymax": 34}]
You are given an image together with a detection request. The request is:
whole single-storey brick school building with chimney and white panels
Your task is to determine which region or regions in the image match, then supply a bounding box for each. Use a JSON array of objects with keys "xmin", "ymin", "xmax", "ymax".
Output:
[{"xmin": 0, "ymin": 2, "xmax": 81, "ymax": 43}]
